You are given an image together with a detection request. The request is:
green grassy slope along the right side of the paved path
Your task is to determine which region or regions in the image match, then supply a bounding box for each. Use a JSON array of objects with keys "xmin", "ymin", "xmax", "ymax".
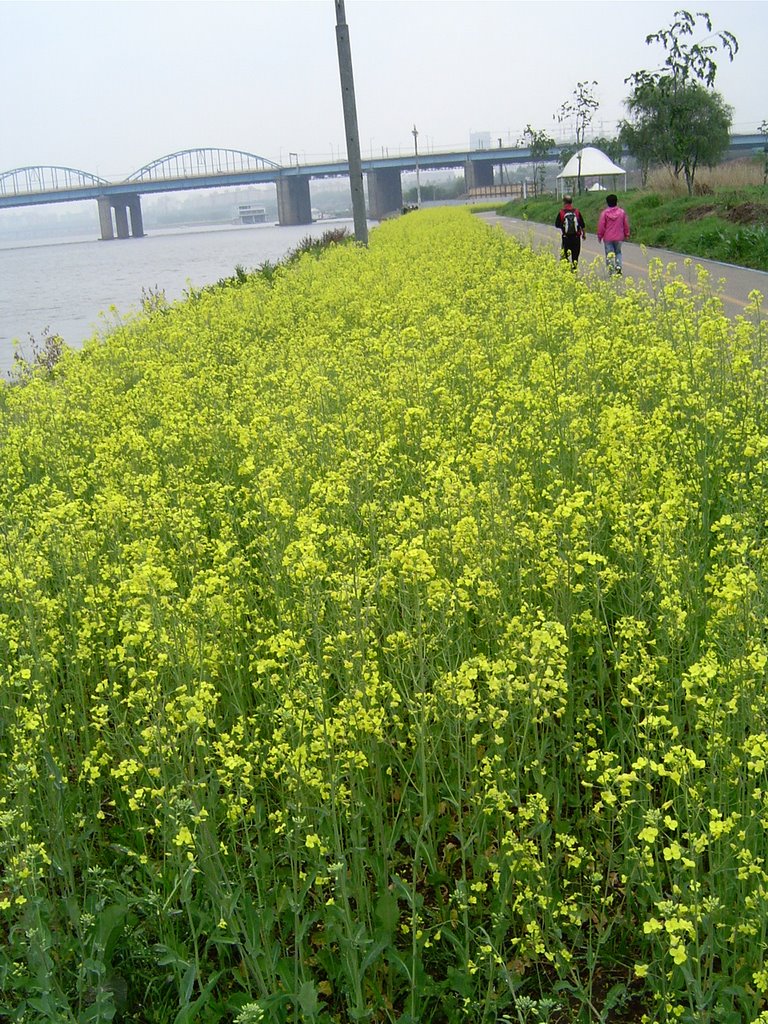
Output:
[{"xmin": 501, "ymin": 186, "xmax": 768, "ymax": 270}]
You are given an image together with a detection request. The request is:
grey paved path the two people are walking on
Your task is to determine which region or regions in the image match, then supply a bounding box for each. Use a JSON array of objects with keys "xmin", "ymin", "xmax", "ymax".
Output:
[{"xmin": 477, "ymin": 213, "xmax": 768, "ymax": 316}]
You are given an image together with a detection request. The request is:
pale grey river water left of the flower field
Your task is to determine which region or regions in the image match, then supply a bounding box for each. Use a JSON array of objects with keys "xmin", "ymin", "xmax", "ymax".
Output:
[{"xmin": 0, "ymin": 220, "xmax": 352, "ymax": 379}]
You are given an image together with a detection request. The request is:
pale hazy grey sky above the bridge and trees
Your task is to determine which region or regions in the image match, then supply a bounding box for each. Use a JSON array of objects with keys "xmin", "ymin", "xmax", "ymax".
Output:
[{"xmin": 0, "ymin": 0, "xmax": 768, "ymax": 180}]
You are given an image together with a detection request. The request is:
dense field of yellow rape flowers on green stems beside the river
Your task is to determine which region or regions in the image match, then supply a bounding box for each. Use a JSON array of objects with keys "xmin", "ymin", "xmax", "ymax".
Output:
[{"xmin": 0, "ymin": 210, "xmax": 768, "ymax": 1024}]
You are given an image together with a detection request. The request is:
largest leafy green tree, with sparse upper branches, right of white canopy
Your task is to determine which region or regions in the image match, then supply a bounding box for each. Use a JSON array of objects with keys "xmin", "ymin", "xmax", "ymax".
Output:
[{"xmin": 621, "ymin": 10, "xmax": 738, "ymax": 194}]
